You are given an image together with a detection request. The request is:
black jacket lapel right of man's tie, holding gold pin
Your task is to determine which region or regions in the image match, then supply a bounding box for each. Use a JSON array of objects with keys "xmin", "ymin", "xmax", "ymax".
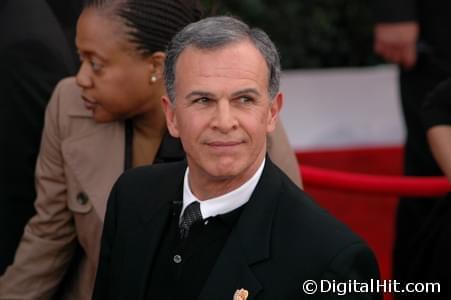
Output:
[{"xmin": 199, "ymin": 158, "xmax": 281, "ymax": 300}]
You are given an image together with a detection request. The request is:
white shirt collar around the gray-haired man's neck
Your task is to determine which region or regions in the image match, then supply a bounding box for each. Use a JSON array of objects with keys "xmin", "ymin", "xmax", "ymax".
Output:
[{"xmin": 180, "ymin": 158, "xmax": 266, "ymax": 219}]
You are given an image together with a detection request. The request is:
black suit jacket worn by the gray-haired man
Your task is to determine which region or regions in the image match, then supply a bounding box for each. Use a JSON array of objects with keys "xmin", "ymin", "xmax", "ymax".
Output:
[{"xmin": 93, "ymin": 159, "xmax": 379, "ymax": 300}]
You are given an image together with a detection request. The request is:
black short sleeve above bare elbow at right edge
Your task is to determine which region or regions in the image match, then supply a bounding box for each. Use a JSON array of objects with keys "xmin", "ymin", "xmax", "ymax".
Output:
[{"xmin": 421, "ymin": 78, "xmax": 451, "ymax": 130}]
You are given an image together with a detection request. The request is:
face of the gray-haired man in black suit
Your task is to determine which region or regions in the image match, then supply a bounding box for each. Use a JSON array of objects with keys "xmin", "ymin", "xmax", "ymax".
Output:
[{"xmin": 163, "ymin": 41, "xmax": 282, "ymax": 182}]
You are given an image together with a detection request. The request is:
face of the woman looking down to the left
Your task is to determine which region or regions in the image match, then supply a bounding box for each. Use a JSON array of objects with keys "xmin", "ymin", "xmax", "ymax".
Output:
[{"xmin": 76, "ymin": 8, "xmax": 164, "ymax": 123}]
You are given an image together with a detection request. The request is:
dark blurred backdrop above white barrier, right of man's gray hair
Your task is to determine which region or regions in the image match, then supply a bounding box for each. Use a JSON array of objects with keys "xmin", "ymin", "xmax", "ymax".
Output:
[{"xmin": 204, "ymin": 0, "xmax": 380, "ymax": 70}]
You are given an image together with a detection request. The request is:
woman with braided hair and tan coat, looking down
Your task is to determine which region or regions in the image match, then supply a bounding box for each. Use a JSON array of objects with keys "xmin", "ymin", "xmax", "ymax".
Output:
[{"xmin": 0, "ymin": 0, "xmax": 300, "ymax": 299}]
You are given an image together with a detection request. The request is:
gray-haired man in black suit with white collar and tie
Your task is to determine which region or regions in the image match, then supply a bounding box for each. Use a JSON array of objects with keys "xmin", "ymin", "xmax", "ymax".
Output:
[{"xmin": 93, "ymin": 17, "xmax": 379, "ymax": 300}]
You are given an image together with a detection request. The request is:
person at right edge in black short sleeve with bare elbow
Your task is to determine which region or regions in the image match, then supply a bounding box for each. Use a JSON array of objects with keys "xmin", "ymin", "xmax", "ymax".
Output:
[{"xmin": 407, "ymin": 78, "xmax": 451, "ymax": 299}]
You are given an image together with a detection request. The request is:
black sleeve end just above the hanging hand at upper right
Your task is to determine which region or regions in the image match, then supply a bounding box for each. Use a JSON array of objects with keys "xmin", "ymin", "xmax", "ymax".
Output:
[{"xmin": 371, "ymin": 0, "xmax": 420, "ymax": 23}]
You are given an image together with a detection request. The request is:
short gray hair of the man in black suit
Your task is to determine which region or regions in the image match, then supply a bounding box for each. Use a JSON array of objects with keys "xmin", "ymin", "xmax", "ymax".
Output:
[{"xmin": 164, "ymin": 16, "xmax": 280, "ymax": 103}]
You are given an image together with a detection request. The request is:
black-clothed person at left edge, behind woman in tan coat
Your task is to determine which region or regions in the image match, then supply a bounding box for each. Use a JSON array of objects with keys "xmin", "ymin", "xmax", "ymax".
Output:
[{"xmin": 0, "ymin": 0, "xmax": 75, "ymax": 274}]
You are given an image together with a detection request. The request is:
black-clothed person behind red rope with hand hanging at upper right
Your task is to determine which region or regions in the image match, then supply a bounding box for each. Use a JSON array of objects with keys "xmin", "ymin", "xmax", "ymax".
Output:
[{"xmin": 373, "ymin": 0, "xmax": 451, "ymax": 288}]
